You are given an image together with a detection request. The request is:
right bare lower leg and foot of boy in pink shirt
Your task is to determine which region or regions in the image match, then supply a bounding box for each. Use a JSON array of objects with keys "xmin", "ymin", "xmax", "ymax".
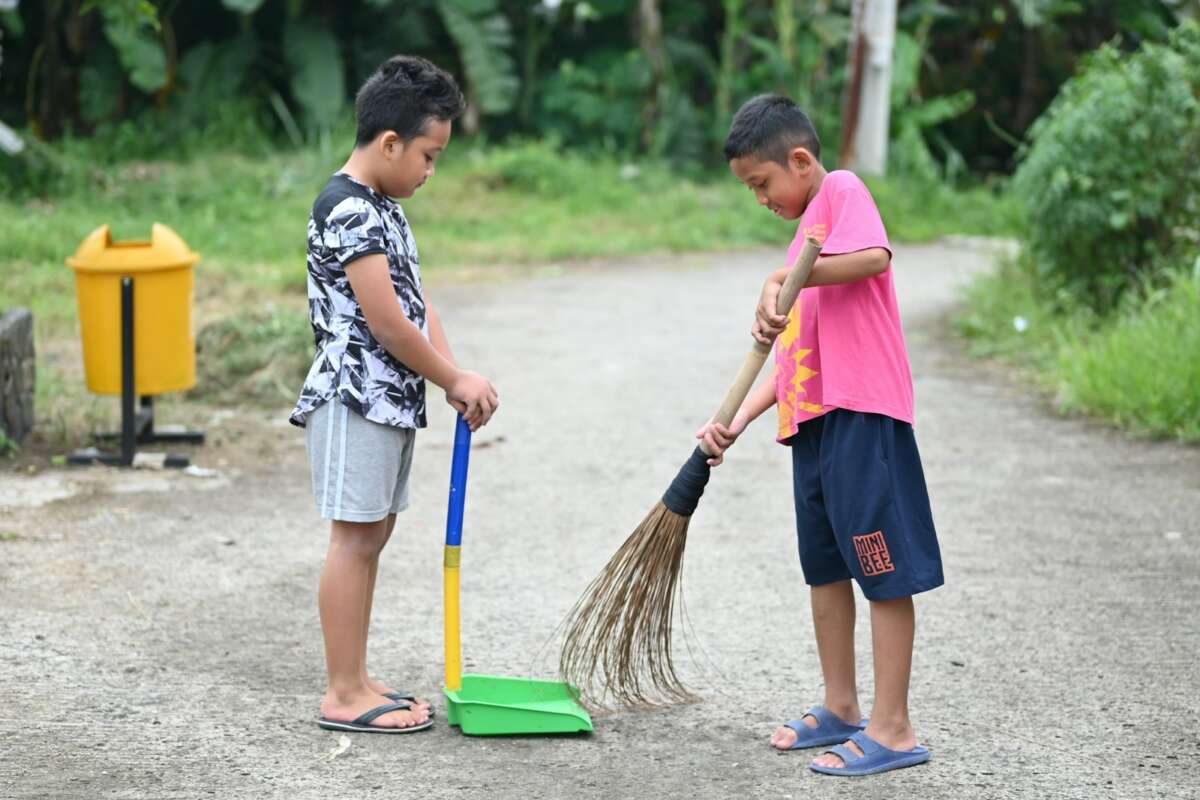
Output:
[{"xmin": 814, "ymin": 597, "xmax": 917, "ymax": 766}]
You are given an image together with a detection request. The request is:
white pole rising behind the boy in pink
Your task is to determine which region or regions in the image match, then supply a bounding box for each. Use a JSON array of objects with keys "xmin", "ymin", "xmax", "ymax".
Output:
[{"xmin": 851, "ymin": 0, "xmax": 896, "ymax": 175}]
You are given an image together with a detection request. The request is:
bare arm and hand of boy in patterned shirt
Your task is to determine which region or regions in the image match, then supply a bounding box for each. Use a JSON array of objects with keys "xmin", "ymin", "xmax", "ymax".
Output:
[{"xmin": 346, "ymin": 253, "xmax": 499, "ymax": 429}]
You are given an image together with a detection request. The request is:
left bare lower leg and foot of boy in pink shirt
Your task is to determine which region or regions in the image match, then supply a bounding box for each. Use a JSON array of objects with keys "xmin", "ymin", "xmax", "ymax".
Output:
[{"xmin": 770, "ymin": 581, "xmax": 863, "ymax": 750}]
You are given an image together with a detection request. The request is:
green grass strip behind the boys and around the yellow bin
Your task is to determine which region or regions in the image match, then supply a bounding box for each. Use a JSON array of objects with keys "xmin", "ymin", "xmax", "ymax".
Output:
[{"xmin": 0, "ymin": 139, "xmax": 1014, "ymax": 453}]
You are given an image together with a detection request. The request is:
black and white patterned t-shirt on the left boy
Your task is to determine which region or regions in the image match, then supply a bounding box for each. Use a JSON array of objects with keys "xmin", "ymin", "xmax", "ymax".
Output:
[{"xmin": 289, "ymin": 173, "xmax": 430, "ymax": 428}]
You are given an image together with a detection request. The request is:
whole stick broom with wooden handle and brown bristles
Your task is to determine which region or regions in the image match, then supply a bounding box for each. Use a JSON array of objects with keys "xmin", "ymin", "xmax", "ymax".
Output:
[{"xmin": 559, "ymin": 239, "xmax": 821, "ymax": 705}]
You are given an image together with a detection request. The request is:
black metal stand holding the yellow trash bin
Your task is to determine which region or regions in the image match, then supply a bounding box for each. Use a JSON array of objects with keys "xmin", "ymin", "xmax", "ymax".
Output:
[{"xmin": 67, "ymin": 278, "xmax": 204, "ymax": 468}]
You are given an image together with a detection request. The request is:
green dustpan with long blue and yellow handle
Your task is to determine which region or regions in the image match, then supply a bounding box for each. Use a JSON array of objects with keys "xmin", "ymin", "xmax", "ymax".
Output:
[{"xmin": 443, "ymin": 416, "xmax": 592, "ymax": 736}]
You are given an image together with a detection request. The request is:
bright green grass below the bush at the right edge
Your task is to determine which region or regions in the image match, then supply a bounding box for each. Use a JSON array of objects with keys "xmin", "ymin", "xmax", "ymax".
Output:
[{"xmin": 955, "ymin": 255, "xmax": 1200, "ymax": 443}]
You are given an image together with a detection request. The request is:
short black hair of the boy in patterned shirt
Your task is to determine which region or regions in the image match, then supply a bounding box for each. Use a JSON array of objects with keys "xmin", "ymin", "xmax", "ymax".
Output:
[{"xmin": 354, "ymin": 55, "xmax": 467, "ymax": 148}]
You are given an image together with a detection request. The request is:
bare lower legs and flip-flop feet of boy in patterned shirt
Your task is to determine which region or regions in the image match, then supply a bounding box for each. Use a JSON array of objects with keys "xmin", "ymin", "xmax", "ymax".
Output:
[{"xmin": 318, "ymin": 519, "xmax": 428, "ymax": 727}]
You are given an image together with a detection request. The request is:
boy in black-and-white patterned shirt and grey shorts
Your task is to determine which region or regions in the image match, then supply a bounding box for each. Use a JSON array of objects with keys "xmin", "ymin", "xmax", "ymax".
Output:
[{"xmin": 290, "ymin": 55, "xmax": 498, "ymax": 733}]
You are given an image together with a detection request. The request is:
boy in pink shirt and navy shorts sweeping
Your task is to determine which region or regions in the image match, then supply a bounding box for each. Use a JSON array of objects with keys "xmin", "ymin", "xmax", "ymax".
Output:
[{"xmin": 698, "ymin": 95, "xmax": 943, "ymax": 775}]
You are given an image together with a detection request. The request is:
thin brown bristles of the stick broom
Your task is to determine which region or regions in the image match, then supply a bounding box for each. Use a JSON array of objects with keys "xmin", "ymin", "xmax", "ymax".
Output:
[{"xmin": 559, "ymin": 503, "xmax": 695, "ymax": 705}]
